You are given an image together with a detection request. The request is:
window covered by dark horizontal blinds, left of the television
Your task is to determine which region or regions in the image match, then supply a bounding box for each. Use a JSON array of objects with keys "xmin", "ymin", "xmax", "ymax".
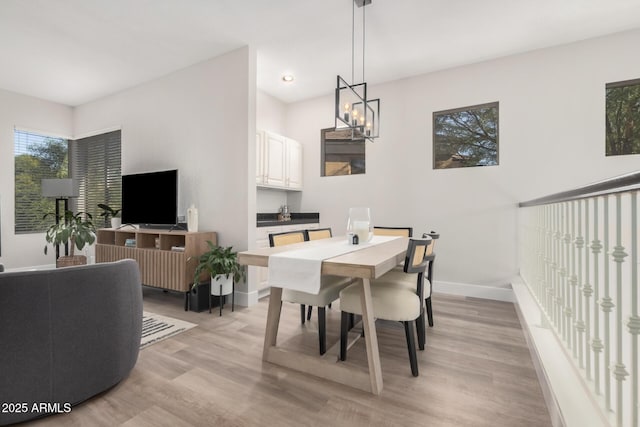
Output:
[{"xmin": 70, "ymin": 130, "xmax": 122, "ymax": 227}]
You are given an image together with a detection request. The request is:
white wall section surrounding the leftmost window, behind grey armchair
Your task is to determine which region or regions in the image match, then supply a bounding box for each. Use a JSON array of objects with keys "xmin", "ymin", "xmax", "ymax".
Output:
[{"xmin": 0, "ymin": 90, "xmax": 73, "ymax": 268}]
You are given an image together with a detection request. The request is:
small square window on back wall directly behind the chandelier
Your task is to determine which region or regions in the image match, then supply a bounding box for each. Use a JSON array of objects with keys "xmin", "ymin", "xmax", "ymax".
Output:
[{"xmin": 320, "ymin": 128, "xmax": 366, "ymax": 176}]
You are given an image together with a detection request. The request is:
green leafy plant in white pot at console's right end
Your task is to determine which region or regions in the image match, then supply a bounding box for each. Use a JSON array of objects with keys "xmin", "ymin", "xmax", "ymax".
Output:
[{"xmin": 192, "ymin": 240, "xmax": 246, "ymax": 312}]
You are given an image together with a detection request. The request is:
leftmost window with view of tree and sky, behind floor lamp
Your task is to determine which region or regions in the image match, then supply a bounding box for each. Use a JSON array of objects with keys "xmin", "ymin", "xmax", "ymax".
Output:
[{"xmin": 14, "ymin": 129, "xmax": 69, "ymax": 234}]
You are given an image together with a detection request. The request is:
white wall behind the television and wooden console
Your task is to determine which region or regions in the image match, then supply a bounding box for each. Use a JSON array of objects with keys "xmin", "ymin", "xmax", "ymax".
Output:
[{"xmin": 74, "ymin": 47, "xmax": 256, "ymax": 256}]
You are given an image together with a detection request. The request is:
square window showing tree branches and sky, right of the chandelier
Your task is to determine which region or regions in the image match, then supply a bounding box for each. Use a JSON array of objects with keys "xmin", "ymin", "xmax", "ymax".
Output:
[{"xmin": 433, "ymin": 102, "xmax": 498, "ymax": 169}]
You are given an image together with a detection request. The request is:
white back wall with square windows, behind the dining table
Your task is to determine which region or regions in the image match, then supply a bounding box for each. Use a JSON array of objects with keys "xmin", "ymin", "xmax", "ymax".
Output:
[{"xmin": 286, "ymin": 31, "xmax": 640, "ymax": 286}]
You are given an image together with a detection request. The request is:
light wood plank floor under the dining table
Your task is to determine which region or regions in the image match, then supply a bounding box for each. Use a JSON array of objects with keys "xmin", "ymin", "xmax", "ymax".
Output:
[{"xmin": 29, "ymin": 288, "xmax": 551, "ymax": 427}]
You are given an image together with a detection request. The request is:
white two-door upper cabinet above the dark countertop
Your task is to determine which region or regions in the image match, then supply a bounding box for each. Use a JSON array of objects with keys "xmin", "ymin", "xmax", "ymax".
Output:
[{"xmin": 256, "ymin": 131, "xmax": 302, "ymax": 190}]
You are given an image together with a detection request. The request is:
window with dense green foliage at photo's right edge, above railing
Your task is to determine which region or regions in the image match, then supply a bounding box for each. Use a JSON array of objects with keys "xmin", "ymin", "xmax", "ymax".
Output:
[{"xmin": 605, "ymin": 79, "xmax": 640, "ymax": 156}]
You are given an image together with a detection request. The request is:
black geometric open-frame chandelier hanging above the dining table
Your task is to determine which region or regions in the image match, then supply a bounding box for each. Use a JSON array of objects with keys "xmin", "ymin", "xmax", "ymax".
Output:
[{"xmin": 335, "ymin": 0, "xmax": 380, "ymax": 142}]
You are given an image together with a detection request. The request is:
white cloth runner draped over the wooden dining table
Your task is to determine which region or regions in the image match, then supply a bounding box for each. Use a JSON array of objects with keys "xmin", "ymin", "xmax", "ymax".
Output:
[{"xmin": 269, "ymin": 236, "xmax": 399, "ymax": 294}]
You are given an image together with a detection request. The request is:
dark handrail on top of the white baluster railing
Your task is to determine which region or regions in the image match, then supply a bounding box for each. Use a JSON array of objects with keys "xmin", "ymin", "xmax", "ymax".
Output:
[{"xmin": 518, "ymin": 171, "xmax": 640, "ymax": 208}]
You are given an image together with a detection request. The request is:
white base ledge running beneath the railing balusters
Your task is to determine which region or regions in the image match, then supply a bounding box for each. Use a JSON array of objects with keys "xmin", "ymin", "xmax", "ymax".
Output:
[{"xmin": 512, "ymin": 277, "xmax": 611, "ymax": 427}]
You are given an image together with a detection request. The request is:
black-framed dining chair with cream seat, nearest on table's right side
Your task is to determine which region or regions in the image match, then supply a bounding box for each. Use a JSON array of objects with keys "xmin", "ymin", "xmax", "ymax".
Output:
[{"xmin": 340, "ymin": 237, "xmax": 433, "ymax": 377}]
